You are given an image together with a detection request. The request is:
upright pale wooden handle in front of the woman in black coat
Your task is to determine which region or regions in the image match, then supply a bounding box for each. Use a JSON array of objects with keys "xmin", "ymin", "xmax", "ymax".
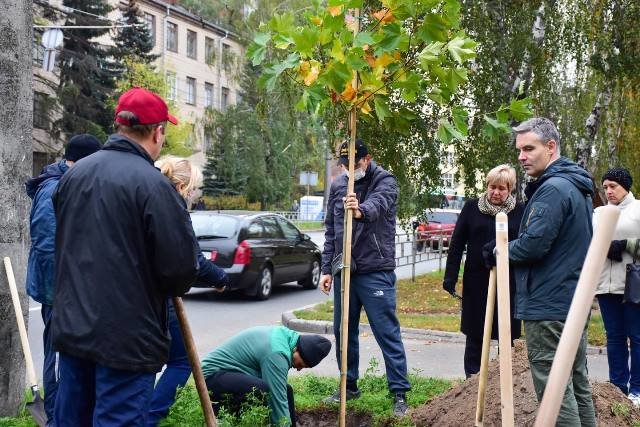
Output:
[{"xmin": 496, "ymin": 212, "xmax": 514, "ymax": 427}]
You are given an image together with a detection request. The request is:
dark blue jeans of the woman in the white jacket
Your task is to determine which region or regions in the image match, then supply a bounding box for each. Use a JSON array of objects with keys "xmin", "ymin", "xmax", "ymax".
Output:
[{"xmin": 598, "ymin": 294, "xmax": 640, "ymax": 395}]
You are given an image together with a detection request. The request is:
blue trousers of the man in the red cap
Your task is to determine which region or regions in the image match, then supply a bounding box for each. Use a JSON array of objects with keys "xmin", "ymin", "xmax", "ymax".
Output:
[{"xmin": 54, "ymin": 353, "xmax": 155, "ymax": 427}]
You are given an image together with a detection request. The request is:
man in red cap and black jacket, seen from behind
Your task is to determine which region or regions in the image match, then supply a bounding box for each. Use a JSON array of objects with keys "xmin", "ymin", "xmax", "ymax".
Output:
[{"xmin": 52, "ymin": 88, "xmax": 198, "ymax": 427}]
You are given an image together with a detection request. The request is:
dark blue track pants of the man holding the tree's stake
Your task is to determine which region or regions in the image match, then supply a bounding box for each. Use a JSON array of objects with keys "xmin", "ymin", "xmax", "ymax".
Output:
[{"xmin": 333, "ymin": 271, "xmax": 411, "ymax": 393}]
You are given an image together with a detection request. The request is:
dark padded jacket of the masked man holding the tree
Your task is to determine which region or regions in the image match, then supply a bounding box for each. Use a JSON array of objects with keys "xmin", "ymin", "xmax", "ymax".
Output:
[{"xmin": 322, "ymin": 162, "xmax": 398, "ymax": 274}]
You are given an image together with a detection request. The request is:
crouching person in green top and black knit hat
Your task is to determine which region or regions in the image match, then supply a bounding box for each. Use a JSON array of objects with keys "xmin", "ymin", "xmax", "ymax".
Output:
[{"xmin": 202, "ymin": 326, "xmax": 331, "ymax": 426}]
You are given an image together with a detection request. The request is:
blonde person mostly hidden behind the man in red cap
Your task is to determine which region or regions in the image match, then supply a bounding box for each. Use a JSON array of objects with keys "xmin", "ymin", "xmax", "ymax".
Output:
[{"xmin": 147, "ymin": 156, "xmax": 229, "ymax": 426}]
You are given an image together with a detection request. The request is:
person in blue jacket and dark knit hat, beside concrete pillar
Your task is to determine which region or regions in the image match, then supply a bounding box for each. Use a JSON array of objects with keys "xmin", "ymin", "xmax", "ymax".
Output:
[{"xmin": 25, "ymin": 134, "xmax": 101, "ymax": 422}]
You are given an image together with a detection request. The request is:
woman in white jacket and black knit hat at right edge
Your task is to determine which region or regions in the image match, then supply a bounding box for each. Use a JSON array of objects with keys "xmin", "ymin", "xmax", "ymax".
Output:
[{"xmin": 593, "ymin": 168, "xmax": 640, "ymax": 406}]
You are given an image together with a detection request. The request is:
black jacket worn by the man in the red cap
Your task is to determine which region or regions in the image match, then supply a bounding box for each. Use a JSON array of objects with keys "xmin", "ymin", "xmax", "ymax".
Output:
[{"xmin": 52, "ymin": 135, "xmax": 198, "ymax": 372}]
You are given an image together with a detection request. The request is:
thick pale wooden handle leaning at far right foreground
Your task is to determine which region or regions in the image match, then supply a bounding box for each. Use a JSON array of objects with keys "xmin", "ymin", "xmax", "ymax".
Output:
[{"xmin": 534, "ymin": 206, "xmax": 620, "ymax": 427}]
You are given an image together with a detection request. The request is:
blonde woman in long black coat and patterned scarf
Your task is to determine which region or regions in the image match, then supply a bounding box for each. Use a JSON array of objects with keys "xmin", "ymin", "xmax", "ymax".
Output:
[{"xmin": 442, "ymin": 165, "xmax": 523, "ymax": 378}]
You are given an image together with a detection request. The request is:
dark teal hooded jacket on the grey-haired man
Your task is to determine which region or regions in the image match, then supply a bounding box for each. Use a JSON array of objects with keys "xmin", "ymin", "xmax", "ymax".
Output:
[{"xmin": 509, "ymin": 157, "xmax": 593, "ymax": 321}]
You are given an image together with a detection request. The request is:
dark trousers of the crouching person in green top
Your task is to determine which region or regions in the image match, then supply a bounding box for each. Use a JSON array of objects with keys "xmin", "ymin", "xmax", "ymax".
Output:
[{"xmin": 205, "ymin": 371, "xmax": 296, "ymax": 427}]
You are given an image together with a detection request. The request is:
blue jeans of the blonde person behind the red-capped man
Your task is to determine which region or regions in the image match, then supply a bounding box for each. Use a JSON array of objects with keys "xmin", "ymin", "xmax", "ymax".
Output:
[{"xmin": 147, "ymin": 300, "xmax": 191, "ymax": 426}]
